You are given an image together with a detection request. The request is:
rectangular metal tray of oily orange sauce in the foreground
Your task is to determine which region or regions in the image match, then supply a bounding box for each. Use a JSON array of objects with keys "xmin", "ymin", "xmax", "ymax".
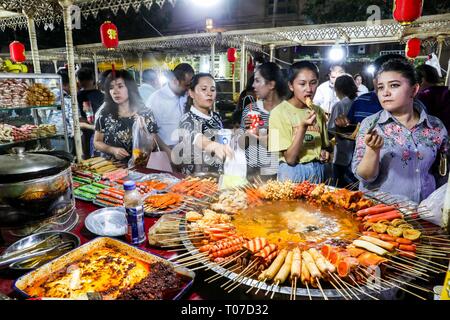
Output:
[{"xmin": 14, "ymin": 237, "xmax": 195, "ymax": 300}]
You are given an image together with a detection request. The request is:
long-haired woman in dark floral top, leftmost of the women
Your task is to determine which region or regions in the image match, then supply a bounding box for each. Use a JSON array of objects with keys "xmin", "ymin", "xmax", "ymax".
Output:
[{"xmin": 94, "ymin": 70, "xmax": 166, "ymax": 163}]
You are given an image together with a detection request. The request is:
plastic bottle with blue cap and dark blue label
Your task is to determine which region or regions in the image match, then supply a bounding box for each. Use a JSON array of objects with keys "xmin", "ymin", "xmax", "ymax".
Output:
[{"xmin": 123, "ymin": 181, "xmax": 146, "ymax": 245}]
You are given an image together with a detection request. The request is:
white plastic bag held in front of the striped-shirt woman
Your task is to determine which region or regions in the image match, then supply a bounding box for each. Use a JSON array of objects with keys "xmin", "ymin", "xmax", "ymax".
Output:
[{"xmin": 219, "ymin": 136, "xmax": 248, "ymax": 189}]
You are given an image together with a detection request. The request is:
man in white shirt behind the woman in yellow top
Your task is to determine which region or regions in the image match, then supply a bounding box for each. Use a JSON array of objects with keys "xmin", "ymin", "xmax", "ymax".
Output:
[{"xmin": 313, "ymin": 65, "xmax": 345, "ymax": 114}]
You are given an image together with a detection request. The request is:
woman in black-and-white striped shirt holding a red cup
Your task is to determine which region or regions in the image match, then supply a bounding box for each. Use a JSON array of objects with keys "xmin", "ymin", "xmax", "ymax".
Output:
[{"xmin": 241, "ymin": 62, "xmax": 287, "ymax": 180}]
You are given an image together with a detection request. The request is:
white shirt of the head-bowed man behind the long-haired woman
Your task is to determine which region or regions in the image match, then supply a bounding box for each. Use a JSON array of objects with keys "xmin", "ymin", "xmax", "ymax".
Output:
[{"xmin": 145, "ymin": 84, "xmax": 187, "ymax": 146}]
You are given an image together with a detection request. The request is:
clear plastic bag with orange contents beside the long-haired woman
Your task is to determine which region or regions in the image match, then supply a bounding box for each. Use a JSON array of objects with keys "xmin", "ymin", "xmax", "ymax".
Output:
[{"xmin": 128, "ymin": 116, "xmax": 153, "ymax": 168}]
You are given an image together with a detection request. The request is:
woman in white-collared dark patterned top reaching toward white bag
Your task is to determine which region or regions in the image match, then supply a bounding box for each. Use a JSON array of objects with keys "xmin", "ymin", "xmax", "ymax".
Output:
[{"xmin": 172, "ymin": 73, "xmax": 233, "ymax": 174}]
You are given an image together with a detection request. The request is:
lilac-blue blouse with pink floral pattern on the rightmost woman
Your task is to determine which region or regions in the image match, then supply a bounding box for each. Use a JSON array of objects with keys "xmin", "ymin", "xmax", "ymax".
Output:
[{"xmin": 352, "ymin": 105, "xmax": 448, "ymax": 203}]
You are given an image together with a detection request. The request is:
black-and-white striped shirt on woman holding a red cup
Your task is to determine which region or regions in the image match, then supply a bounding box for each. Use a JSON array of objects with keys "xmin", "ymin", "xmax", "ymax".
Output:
[{"xmin": 241, "ymin": 100, "xmax": 278, "ymax": 175}]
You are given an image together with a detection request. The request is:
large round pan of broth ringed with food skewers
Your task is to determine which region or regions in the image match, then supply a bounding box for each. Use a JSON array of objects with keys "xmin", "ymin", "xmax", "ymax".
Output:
[{"xmin": 171, "ymin": 181, "xmax": 450, "ymax": 300}]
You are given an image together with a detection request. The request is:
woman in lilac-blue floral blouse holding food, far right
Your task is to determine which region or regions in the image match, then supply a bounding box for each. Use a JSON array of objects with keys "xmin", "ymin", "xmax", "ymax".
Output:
[{"xmin": 352, "ymin": 60, "xmax": 448, "ymax": 203}]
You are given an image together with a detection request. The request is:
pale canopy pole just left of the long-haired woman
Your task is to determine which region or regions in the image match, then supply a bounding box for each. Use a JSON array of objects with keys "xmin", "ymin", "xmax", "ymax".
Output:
[{"xmin": 59, "ymin": 0, "xmax": 83, "ymax": 162}]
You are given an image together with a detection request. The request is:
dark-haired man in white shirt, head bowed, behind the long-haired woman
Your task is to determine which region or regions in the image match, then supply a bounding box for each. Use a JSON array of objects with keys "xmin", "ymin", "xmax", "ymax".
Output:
[{"xmin": 145, "ymin": 63, "xmax": 194, "ymax": 148}]
